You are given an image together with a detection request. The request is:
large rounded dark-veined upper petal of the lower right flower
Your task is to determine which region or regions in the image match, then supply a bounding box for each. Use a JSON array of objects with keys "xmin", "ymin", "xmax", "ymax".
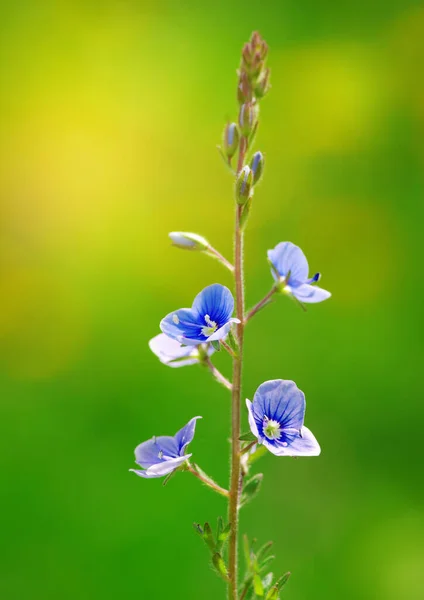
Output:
[{"xmin": 253, "ymin": 379, "xmax": 306, "ymax": 433}]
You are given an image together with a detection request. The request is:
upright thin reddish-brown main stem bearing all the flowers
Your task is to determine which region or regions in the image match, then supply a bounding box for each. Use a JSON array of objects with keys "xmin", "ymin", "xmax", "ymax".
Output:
[{"xmin": 228, "ymin": 204, "xmax": 244, "ymax": 600}]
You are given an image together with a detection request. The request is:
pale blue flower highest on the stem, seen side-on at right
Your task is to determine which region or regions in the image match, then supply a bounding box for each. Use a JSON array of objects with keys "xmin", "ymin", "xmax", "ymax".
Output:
[{"xmin": 268, "ymin": 242, "xmax": 331, "ymax": 302}]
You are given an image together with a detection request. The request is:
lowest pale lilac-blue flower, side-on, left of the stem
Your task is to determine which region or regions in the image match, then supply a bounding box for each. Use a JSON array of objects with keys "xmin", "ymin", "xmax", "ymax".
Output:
[{"xmin": 130, "ymin": 417, "xmax": 202, "ymax": 479}]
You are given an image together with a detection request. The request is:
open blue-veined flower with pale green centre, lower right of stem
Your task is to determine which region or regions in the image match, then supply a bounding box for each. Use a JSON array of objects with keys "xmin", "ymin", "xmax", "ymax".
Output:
[{"xmin": 246, "ymin": 379, "xmax": 321, "ymax": 456}]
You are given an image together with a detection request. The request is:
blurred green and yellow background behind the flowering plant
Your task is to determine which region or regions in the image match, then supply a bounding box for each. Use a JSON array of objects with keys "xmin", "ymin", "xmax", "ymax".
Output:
[{"xmin": 0, "ymin": 0, "xmax": 424, "ymax": 600}]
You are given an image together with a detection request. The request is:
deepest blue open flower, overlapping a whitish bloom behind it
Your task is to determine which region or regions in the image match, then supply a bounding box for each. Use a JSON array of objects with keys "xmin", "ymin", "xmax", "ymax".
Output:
[{"xmin": 160, "ymin": 283, "xmax": 240, "ymax": 346}]
